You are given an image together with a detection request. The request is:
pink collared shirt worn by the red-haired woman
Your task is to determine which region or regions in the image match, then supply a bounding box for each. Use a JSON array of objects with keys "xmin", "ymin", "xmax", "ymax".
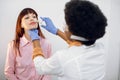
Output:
[{"xmin": 4, "ymin": 36, "xmax": 51, "ymax": 80}]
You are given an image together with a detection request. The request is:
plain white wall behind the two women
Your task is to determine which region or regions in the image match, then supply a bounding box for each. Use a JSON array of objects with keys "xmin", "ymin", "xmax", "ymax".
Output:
[{"xmin": 0, "ymin": 0, "xmax": 120, "ymax": 80}]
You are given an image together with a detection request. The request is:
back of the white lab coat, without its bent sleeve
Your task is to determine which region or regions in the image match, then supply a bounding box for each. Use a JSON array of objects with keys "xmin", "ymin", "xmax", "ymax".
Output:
[{"xmin": 55, "ymin": 43, "xmax": 105, "ymax": 80}]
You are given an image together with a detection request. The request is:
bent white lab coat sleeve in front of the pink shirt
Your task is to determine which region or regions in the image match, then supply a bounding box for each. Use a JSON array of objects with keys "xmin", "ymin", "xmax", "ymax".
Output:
[{"xmin": 33, "ymin": 53, "xmax": 63, "ymax": 76}]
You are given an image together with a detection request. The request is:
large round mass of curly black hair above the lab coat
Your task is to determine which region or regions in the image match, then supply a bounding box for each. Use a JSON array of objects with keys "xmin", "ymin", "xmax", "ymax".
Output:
[{"xmin": 64, "ymin": 0, "xmax": 107, "ymax": 45}]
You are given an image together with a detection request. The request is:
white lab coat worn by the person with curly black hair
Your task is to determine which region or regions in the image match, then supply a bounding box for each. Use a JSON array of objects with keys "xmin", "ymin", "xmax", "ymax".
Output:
[{"xmin": 34, "ymin": 44, "xmax": 105, "ymax": 80}]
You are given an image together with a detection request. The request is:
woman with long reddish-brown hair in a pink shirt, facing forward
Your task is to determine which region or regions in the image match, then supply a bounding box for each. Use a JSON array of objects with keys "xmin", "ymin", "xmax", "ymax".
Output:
[{"xmin": 4, "ymin": 8, "xmax": 51, "ymax": 80}]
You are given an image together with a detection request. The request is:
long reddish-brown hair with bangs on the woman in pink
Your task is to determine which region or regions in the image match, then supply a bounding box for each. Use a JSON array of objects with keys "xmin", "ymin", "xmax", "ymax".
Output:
[{"xmin": 14, "ymin": 8, "xmax": 45, "ymax": 56}]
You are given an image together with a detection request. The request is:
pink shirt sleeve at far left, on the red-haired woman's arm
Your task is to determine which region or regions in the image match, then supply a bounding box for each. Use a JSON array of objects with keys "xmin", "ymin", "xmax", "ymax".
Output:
[{"xmin": 4, "ymin": 43, "xmax": 18, "ymax": 80}]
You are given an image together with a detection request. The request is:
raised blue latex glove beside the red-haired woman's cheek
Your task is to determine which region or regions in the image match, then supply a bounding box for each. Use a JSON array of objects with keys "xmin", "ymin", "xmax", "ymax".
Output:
[{"xmin": 40, "ymin": 17, "xmax": 58, "ymax": 34}]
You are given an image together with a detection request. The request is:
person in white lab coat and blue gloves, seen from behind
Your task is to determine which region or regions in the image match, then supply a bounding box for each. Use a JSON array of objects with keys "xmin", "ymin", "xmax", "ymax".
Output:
[{"xmin": 29, "ymin": 0, "xmax": 107, "ymax": 80}]
